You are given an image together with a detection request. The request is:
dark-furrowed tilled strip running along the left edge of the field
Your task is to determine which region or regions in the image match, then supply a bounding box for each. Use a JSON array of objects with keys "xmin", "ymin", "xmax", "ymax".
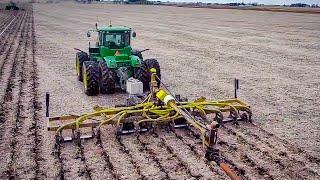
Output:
[{"xmin": 0, "ymin": 5, "xmax": 41, "ymax": 179}]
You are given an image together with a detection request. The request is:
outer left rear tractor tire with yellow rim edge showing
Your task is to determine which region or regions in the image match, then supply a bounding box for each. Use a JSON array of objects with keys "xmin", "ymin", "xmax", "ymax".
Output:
[{"xmin": 82, "ymin": 61, "xmax": 99, "ymax": 96}]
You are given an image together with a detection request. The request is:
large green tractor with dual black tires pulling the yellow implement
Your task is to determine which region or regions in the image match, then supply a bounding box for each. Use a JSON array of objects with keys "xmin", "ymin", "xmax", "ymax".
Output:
[{"xmin": 75, "ymin": 24, "xmax": 161, "ymax": 96}]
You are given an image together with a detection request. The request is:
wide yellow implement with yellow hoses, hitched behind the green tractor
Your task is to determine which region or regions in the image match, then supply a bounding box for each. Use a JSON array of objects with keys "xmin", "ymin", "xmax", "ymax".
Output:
[{"xmin": 48, "ymin": 70, "xmax": 252, "ymax": 147}]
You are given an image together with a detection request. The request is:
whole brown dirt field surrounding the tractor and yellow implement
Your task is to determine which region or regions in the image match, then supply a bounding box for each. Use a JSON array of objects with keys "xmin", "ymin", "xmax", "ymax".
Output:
[{"xmin": 0, "ymin": 3, "xmax": 320, "ymax": 179}]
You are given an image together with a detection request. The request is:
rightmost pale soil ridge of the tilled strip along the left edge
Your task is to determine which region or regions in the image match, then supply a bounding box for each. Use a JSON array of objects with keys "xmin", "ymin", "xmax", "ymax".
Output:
[{"xmin": 12, "ymin": 6, "xmax": 43, "ymax": 179}]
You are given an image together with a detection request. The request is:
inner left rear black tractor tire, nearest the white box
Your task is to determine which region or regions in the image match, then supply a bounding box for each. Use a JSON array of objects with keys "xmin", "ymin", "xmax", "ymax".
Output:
[{"xmin": 99, "ymin": 61, "xmax": 116, "ymax": 94}]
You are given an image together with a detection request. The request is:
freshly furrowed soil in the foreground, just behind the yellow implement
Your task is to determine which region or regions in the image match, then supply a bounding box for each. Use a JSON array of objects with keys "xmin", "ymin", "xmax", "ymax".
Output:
[{"xmin": 48, "ymin": 123, "xmax": 320, "ymax": 179}]
